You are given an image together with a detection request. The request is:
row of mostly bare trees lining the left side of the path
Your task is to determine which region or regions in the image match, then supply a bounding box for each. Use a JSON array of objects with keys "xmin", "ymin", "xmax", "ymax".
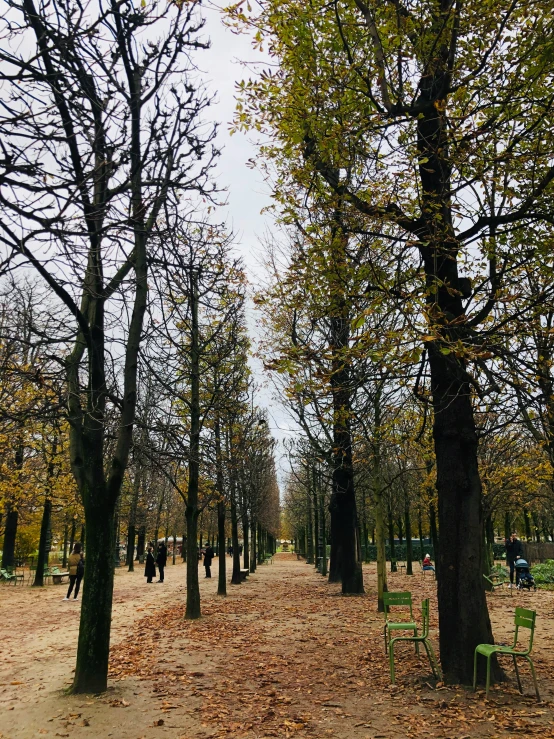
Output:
[{"xmin": 0, "ymin": 0, "xmax": 278, "ymax": 692}]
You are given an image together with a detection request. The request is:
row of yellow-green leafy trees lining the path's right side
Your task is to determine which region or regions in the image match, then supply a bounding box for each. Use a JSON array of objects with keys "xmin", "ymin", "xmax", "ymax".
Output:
[{"xmin": 227, "ymin": 0, "xmax": 554, "ymax": 682}]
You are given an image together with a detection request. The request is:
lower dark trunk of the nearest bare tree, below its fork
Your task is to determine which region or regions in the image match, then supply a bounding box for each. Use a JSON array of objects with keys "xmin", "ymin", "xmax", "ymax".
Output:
[{"xmin": 72, "ymin": 496, "xmax": 115, "ymax": 693}]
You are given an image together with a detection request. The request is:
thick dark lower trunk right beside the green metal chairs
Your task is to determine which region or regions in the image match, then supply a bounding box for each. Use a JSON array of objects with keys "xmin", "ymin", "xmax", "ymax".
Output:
[{"xmin": 424, "ymin": 349, "xmax": 494, "ymax": 683}]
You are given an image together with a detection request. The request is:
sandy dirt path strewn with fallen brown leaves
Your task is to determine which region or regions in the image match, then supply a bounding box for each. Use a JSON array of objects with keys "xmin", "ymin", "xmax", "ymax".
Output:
[{"xmin": 0, "ymin": 555, "xmax": 554, "ymax": 739}]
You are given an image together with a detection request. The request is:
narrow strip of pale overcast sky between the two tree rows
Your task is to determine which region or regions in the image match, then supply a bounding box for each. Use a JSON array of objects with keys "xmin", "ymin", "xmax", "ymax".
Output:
[{"xmin": 198, "ymin": 8, "xmax": 292, "ymax": 479}]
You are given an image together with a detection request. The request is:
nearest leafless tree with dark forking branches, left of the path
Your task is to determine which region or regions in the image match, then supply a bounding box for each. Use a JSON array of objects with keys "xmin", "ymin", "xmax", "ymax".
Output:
[{"xmin": 0, "ymin": 0, "xmax": 213, "ymax": 693}]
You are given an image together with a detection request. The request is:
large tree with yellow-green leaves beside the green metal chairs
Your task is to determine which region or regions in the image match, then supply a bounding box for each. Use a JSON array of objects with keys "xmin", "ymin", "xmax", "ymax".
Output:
[{"xmin": 225, "ymin": 0, "xmax": 554, "ymax": 682}]
